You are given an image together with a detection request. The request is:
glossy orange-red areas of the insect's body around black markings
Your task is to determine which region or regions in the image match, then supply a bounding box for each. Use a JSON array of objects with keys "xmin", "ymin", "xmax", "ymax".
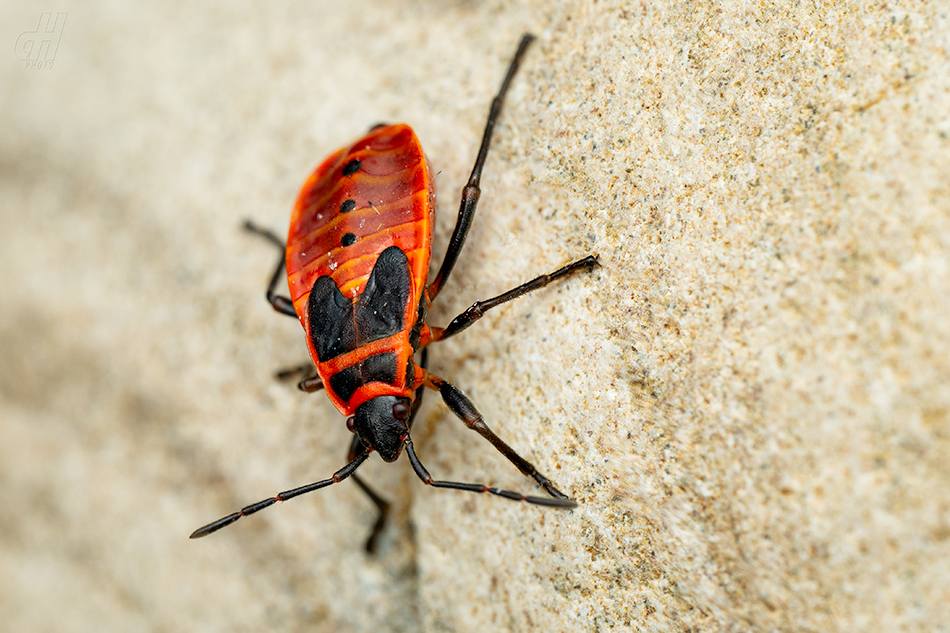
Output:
[{"xmin": 286, "ymin": 124, "xmax": 435, "ymax": 415}]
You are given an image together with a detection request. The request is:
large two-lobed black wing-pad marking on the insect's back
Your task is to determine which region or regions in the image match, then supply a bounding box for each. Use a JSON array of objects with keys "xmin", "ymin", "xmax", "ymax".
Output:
[{"xmin": 307, "ymin": 246, "xmax": 412, "ymax": 362}]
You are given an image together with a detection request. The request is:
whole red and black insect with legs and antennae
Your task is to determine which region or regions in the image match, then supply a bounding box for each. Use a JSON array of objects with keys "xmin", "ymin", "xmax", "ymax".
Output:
[{"xmin": 191, "ymin": 35, "xmax": 597, "ymax": 551}]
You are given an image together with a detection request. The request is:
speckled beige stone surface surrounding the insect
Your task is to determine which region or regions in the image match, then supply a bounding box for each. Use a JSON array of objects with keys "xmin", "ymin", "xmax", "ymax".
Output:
[{"xmin": 0, "ymin": 0, "xmax": 950, "ymax": 633}]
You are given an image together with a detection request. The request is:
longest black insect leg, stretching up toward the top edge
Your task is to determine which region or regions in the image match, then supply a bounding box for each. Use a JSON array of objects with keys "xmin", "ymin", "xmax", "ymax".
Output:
[{"xmin": 426, "ymin": 33, "xmax": 534, "ymax": 301}]
